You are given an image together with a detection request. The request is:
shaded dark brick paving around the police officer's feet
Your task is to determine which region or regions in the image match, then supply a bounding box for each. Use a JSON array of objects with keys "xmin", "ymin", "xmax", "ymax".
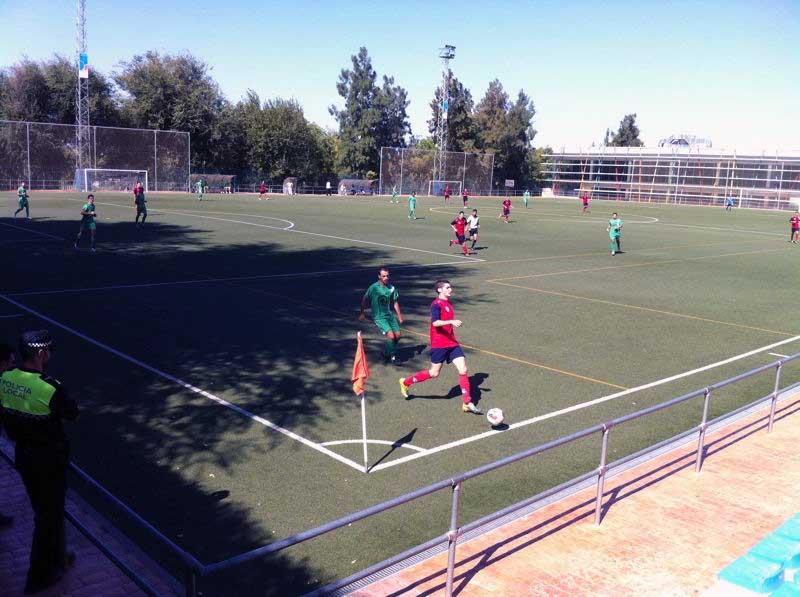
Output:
[{"xmin": 0, "ymin": 440, "xmax": 179, "ymax": 597}]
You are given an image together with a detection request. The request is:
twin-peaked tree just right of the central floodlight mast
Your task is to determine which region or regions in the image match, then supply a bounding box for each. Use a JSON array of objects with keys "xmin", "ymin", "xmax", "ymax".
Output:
[{"xmin": 474, "ymin": 79, "xmax": 536, "ymax": 184}]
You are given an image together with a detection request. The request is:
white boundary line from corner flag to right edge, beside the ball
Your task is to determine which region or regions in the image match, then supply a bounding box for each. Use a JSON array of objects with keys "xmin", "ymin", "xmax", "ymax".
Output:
[{"xmin": 370, "ymin": 336, "xmax": 800, "ymax": 472}]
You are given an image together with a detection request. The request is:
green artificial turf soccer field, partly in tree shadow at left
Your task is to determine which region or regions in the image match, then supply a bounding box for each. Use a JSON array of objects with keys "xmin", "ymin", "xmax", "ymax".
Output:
[{"xmin": 0, "ymin": 191, "xmax": 800, "ymax": 595}]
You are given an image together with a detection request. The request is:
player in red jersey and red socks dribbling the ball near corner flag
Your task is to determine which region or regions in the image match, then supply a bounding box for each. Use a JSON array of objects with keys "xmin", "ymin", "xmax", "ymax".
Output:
[{"xmin": 400, "ymin": 280, "xmax": 482, "ymax": 415}]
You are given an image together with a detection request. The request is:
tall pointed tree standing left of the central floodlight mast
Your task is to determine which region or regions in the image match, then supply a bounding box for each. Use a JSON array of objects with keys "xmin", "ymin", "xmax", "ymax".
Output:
[{"xmin": 328, "ymin": 47, "xmax": 411, "ymax": 177}]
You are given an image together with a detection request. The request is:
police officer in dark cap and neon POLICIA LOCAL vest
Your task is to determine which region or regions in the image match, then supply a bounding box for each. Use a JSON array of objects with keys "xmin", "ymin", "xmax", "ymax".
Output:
[{"xmin": 0, "ymin": 330, "xmax": 78, "ymax": 595}]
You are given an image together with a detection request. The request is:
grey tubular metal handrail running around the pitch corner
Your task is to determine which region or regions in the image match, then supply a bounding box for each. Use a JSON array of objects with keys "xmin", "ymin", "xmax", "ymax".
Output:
[{"xmin": 0, "ymin": 353, "xmax": 800, "ymax": 597}]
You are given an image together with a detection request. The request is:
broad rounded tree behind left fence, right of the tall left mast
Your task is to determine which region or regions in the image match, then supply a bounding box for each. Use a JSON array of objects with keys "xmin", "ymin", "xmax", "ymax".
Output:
[{"xmin": 114, "ymin": 52, "xmax": 227, "ymax": 168}]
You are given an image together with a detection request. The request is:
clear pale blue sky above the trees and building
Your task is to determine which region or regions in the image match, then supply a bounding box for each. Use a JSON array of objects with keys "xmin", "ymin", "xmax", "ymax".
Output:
[{"xmin": 0, "ymin": 0, "xmax": 800, "ymax": 152}]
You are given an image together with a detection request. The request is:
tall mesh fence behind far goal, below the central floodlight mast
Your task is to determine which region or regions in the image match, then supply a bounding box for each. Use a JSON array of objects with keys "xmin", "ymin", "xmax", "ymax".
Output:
[{"xmin": 380, "ymin": 147, "xmax": 494, "ymax": 194}]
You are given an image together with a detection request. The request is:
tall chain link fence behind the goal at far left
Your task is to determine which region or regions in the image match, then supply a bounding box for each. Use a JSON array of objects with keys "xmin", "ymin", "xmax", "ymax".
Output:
[{"xmin": 0, "ymin": 120, "xmax": 191, "ymax": 191}]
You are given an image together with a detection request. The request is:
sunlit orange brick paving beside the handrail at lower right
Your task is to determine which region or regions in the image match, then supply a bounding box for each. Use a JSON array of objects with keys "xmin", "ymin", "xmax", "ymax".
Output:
[{"xmin": 355, "ymin": 395, "xmax": 800, "ymax": 597}]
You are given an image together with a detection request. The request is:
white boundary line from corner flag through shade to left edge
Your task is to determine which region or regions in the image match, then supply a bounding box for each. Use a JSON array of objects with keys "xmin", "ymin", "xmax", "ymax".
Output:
[{"xmin": 0, "ymin": 294, "xmax": 364, "ymax": 472}]
